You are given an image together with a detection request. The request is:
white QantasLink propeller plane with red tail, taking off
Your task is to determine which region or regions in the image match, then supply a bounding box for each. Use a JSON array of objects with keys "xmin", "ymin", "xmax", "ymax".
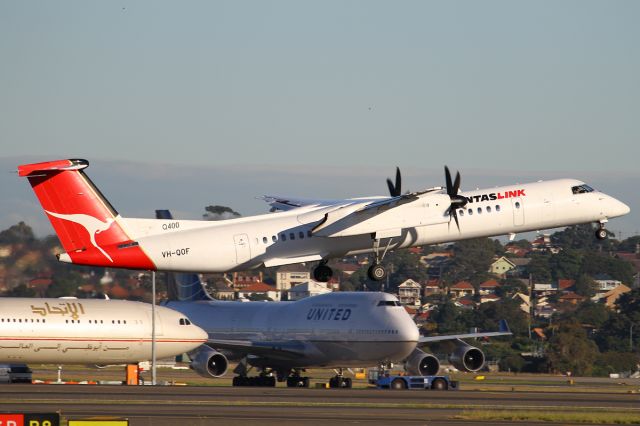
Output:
[{"xmin": 18, "ymin": 159, "xmax": 630, "ymax": 281}]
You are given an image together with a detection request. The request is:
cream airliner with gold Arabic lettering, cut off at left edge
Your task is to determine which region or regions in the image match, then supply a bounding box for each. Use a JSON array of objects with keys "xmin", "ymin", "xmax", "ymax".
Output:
[{"xmin": 0, "ymin": 298, "xmax": 207, "ymax": 364}]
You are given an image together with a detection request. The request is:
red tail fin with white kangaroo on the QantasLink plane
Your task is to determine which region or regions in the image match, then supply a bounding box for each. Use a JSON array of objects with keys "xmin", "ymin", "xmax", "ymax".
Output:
[{"xmin": 18, "ymin": 159, "xmax": 155, "ymax": 269}]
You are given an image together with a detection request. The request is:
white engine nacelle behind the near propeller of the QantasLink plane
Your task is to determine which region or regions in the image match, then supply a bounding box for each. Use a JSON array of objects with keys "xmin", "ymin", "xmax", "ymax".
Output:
[{"xmin": 308, "ymin": 192, "xmax": 451, "ymax": 237}]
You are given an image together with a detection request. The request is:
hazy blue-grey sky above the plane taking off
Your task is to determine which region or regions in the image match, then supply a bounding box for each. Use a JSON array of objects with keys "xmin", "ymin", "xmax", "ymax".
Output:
[{"xmin": 0, "ymin": 0, "xmax": 640, "ymax": 236}]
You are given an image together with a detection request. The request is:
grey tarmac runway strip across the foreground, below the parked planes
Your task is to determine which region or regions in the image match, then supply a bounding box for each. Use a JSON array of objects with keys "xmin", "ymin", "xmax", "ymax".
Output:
[{"xmin": 0, "ymin": 384, "xmax": 640, "ymax": 426}]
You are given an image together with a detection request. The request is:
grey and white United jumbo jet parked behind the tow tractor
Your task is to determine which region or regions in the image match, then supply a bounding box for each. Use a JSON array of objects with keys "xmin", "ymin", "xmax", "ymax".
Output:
[{"xmin": 165, "ymin": 273, "xmax": 511, "ymax": 388}]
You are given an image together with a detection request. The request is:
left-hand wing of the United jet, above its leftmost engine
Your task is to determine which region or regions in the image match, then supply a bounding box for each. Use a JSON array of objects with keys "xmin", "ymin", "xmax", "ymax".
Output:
[{"xmin": 207, "ymin": 339, "xmax": 308, "ymax": 360}]
